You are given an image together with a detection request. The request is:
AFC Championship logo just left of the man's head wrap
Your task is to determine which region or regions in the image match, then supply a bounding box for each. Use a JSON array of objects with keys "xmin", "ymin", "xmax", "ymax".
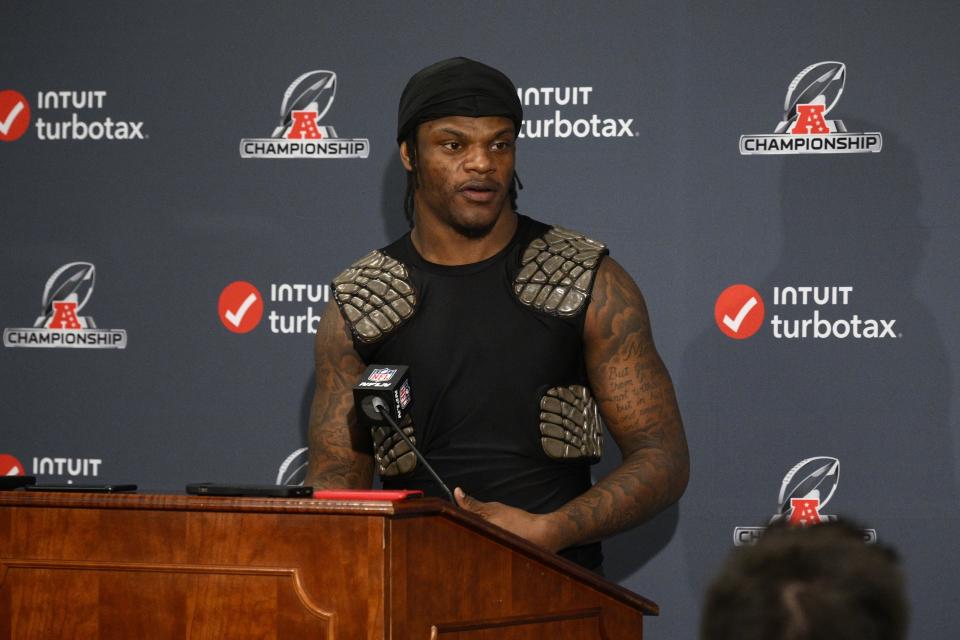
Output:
[{"xmin": 240, "ymin": 70, "xmax": 370, "ymax": 158}]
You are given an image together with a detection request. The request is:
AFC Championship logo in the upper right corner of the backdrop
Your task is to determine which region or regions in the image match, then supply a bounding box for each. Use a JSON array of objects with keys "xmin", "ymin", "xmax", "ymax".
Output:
[{"xmin": 740, "ymin": 61, "xmax": 883, "ymax": 155}]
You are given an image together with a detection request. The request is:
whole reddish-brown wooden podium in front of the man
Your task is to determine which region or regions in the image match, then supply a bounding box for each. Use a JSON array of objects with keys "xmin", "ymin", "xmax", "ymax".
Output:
[{"xmin": 0, "ymin": 491, "xmax": 658, "ymax": 640}]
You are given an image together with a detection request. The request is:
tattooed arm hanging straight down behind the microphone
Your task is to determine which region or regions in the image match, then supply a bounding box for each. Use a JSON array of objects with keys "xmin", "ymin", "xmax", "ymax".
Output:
[{"xmin": 304, "ymin": 300, "xmax": 373, "ymax": 489}]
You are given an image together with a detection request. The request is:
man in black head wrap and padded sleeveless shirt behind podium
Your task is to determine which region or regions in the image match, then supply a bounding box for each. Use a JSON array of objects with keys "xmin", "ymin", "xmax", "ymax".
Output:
[{"xmin": 306, "ymin": 58, "xmax": 688, "ymax": 569}]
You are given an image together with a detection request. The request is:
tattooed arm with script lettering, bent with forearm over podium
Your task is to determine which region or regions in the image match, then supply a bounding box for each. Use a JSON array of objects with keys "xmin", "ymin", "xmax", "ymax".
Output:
[{"xmin": 456, "ymin": 258, "xmax": 689, "ymax": 551}]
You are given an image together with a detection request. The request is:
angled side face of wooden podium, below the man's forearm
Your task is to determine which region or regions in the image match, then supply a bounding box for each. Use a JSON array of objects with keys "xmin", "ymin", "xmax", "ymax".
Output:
[{"xmin": 390, "ymin": 516, "xmax": 643, "ymax": 640}]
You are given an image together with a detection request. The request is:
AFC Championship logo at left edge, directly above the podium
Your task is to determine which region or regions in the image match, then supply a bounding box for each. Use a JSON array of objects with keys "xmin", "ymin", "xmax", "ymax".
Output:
[{"xmin": 3, "ymin": 262, "xmax": 127, "ymax": 349}]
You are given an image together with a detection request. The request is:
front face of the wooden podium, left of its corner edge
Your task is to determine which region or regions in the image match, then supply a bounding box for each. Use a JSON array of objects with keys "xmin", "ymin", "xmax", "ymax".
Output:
[{"xmin": 0, "ymin": 494, "xmax": 389, "ymax": 640}]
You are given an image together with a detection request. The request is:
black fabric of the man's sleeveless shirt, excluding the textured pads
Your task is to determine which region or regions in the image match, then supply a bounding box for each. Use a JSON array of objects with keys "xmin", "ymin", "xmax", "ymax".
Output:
[{"xmin": 338, "ymin": 215, "xmax": 606, "ymax": 568}]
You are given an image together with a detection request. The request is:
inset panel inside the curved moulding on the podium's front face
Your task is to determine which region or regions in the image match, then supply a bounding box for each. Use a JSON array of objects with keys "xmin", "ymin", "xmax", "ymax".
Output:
[{"xmin": 0, "ymin": 561, "xmax": 335, "ymax": 639}]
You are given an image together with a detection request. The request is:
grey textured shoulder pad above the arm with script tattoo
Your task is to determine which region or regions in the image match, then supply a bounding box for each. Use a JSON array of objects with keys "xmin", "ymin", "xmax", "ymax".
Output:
[{"xmin": 513, "ymin": 227, "xmax": 607, "ymax": 316}]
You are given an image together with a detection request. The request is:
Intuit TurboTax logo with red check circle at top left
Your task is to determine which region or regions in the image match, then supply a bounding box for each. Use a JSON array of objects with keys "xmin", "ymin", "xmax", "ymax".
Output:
[{"xmin": 0, "ymin": 89, "xmax": 150, "ymax": 142}]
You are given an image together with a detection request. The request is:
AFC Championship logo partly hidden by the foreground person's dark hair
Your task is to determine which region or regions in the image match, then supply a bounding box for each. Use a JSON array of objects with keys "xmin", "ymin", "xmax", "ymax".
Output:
[{"xmin": 733, "ymin": 456, "xmax": 877, "ymax": 546}]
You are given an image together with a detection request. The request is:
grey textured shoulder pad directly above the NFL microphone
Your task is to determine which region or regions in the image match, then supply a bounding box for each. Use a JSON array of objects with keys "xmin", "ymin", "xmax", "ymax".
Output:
[{"xmin": 333, "ymin": 251, "xmax": 417, "ymax": 343}]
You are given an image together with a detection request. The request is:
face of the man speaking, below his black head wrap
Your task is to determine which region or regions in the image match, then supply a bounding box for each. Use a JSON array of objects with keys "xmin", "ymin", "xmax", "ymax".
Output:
[{"xmin": 400, "ymin": 116, "xmax": 515, "ymax": 238}]
